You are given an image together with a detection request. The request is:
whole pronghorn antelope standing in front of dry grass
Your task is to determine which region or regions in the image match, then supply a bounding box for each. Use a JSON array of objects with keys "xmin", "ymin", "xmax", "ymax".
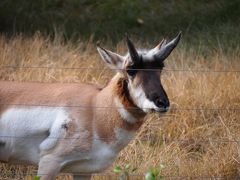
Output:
[{"xmin": 0, "ymin": 33, "xmax": 181, "ymax": 180}]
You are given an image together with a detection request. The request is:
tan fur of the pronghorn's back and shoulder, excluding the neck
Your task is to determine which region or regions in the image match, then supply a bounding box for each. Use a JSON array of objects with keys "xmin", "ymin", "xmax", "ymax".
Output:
[{"xmin": 0, "ymin": 82, "xmax": 99, "ymax": 155}]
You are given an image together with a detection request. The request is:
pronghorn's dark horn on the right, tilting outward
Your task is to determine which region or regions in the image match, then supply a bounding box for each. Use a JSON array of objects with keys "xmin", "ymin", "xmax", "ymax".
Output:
[{"xmin": 154, "ymin": 32, "xmax": 182, "ymax": 61}]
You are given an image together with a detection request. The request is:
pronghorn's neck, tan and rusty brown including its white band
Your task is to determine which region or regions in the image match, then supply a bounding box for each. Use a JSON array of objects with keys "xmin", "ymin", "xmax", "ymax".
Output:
[{"xmin": 95, "ymin": 74, "xmax": 146, "ymax": 142}]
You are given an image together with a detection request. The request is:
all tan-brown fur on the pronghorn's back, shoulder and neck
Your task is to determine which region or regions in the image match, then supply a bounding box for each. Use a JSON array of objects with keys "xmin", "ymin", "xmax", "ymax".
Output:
[{"xmin": 0, "ymin": 75, "xmax": 145, "ymax": 148}]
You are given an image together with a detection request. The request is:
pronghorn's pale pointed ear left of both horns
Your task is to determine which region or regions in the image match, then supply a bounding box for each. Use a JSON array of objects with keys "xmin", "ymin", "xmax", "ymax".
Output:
[{"xmin": 97, "ymin": 46, "xmax": 124, "ymax": 71}]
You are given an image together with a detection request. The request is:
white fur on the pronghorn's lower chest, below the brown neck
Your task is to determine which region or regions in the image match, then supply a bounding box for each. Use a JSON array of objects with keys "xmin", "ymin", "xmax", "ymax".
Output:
[{"xmin": 57, "ymin": 127, "xmax": 135, "ymax": 173}]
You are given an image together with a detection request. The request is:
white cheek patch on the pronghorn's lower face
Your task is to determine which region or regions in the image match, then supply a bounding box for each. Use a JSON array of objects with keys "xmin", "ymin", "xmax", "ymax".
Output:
[{"xmin": 129, "ymin": 82, "xmax": 159, "ymax": 113}]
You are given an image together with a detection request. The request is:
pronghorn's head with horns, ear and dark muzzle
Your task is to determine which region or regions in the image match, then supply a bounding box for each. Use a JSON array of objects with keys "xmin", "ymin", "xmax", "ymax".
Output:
[{"xmin": 97, "ymin": 33, "xmax": 181, "ymax": 112}]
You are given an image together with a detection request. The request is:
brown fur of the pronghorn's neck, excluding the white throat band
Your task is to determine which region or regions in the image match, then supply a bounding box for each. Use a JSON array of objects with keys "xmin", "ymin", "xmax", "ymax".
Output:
[{"xmin": 94, "ymin": 75, "xmax": 145, "ymax": 142}]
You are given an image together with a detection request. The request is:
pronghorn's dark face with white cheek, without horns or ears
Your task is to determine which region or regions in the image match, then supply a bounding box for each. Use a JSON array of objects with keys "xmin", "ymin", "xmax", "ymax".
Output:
[{"xmin": 126, "ymin": 57, "xmax": 170, "ymax": 112}]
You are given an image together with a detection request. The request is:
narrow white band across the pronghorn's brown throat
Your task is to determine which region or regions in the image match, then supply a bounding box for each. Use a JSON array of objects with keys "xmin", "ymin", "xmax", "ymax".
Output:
[{"xmin": 114, "ymin": 97, "xmax": 137, "ymax": 124}]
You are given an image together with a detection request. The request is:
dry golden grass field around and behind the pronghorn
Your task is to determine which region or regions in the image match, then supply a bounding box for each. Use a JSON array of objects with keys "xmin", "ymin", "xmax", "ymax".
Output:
[{"xmin": 0, "ymin": 34, "xmax": 240, "ymax": 180}]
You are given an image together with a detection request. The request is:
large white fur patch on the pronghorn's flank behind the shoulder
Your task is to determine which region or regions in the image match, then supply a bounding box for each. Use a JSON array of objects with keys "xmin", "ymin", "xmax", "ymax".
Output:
[{"xmin": 0, "ymin": 107, "xmax": 68, "ymax": 164}]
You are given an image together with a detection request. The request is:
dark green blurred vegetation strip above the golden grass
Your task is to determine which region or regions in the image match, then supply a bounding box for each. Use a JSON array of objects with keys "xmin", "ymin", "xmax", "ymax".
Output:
[{"xmin": 0, "ymin": 0, "xmax": 240, "ymax": 48}]
